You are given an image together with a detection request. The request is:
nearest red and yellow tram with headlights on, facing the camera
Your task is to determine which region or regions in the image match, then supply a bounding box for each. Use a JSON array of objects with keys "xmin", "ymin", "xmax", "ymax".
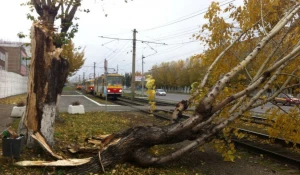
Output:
[{"xmin": 94, "ymin": 74, "xmax": 123, "ymax": 98}]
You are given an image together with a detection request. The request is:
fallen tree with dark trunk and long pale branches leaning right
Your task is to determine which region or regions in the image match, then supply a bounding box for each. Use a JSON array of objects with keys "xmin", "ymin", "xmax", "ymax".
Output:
[{"xmin": 71, "ymin": 3, "xmax": 300, "ymax": 174}]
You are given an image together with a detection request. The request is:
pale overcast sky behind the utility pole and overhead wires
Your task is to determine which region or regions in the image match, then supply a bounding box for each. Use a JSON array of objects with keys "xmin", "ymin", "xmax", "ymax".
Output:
[{"xmin": 0, "ymin": 0, "xmax": 242, "ymax": 80}]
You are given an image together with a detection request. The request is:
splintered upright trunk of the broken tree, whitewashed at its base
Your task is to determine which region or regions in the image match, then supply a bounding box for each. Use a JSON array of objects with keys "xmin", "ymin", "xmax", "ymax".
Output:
[{"xmin": 19, "ymin": 23, "xmax": 69, "ymax": 147}]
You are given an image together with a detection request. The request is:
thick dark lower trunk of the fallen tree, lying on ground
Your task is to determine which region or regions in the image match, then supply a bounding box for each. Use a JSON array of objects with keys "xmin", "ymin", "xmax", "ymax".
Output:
[{"xmin": 69, "ymin": 123, "xmax": 207, "ymax": 174}]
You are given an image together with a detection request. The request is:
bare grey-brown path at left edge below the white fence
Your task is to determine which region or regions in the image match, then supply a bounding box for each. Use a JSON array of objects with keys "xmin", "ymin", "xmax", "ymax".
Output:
[{"xmin": 0, "ymin": 104, "xmax": 14, "ymax": 134}]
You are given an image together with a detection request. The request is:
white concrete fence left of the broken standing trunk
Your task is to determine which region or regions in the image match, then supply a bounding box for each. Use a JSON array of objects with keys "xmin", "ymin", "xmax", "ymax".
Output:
[{"xmin": 0, "ymin": 70, "xmax": 28, "ymax": 98}]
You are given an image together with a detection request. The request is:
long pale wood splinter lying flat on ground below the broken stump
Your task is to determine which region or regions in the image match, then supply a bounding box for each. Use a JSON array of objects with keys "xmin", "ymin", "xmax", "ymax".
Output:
[{"xmin": 15, "ymin": 157, "xmax": 91, "ymax": 166}]
